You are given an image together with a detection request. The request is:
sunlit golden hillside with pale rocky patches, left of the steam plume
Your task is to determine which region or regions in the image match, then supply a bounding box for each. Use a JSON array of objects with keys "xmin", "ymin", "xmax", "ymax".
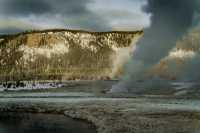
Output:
[{"xmin": 0, "ymin": 30, "xmax": 143, "ymax": 80}]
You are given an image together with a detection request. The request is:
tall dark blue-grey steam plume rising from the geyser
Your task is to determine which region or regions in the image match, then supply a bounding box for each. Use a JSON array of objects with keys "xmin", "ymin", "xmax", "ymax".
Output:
[{"xmin": 111, "ymin": 0, "xmax": 199, "ymax": 92}]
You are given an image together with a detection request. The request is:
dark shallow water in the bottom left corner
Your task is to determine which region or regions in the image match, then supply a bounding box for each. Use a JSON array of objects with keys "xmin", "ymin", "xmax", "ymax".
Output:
[{"xmin": 0, "ymin": 112, "xmax": 96, "ymax": 133}]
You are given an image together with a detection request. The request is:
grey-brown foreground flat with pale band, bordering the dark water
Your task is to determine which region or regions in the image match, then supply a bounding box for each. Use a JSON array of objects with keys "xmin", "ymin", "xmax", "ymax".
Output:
[{"xmin": 0, "ymin": 97, "xmax": 200, "ymax": 133}]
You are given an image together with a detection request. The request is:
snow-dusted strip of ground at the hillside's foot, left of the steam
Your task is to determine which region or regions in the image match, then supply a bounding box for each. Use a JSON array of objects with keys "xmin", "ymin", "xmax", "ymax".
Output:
[{"xmin": 0, "ymin": 80, "xmax": 117, "ymax": 92}]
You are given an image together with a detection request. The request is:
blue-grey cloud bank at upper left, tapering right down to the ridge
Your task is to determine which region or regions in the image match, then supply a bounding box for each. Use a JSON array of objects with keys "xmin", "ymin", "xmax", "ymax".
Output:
[{"xmin": 0, "ymin": 0, "xmax": 111, "ymax": 33}]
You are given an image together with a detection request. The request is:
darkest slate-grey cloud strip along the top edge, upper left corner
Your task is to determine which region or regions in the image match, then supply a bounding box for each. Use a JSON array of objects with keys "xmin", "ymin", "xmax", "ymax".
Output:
[{"xmin": 0, "ymin": 0, "xmax": 89, "ymax": 15}]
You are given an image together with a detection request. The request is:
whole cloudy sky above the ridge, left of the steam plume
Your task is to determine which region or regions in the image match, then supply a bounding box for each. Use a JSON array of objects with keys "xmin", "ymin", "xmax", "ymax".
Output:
[{"xmin": 0, "ymin": 0, "xmax": 150, "ymax": 33}]
